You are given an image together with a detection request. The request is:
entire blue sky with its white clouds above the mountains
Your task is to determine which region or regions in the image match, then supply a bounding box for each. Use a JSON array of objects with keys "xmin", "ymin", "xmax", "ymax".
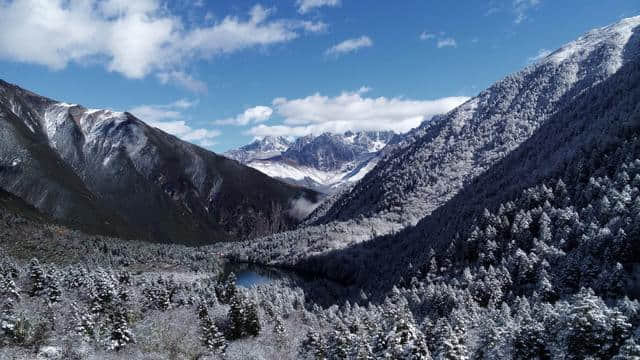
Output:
[{"xmin": 0, "ymin": 0, "xmax": 640, "ymax": 152}]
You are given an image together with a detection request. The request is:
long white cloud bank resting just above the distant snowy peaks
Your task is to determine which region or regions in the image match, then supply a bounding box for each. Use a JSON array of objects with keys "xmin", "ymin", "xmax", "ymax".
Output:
[{"xmin": 246, "ymin": 87, "xmax": 468, "ymax": 136}]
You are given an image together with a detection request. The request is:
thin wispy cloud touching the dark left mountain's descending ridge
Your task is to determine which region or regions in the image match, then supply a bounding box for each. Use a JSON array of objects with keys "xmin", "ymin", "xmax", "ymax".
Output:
[{"xmin": 129, "ymin": 99, "xmax": 220, "ymax": 147}]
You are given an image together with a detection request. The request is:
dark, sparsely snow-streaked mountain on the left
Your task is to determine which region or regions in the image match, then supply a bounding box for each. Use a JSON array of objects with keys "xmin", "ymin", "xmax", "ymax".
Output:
[{"xmin": 0, "ymin": 81, "xmax": 315, "ymax": 244}]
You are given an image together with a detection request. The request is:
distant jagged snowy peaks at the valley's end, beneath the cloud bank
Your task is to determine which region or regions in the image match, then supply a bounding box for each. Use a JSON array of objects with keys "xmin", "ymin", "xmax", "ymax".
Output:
[{"xmin": 225, "ymin": 131, "xmax": 395, "ymax": 192}]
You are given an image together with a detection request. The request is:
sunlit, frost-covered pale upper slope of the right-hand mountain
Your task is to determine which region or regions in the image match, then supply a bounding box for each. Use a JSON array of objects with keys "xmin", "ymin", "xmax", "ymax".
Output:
[{"xmin": 314, "ymin": 17, "xmax": 640, "ymax": 224}]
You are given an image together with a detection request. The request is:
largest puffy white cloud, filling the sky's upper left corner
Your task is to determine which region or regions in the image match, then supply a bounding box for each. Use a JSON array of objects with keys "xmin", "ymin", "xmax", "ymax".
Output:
[{"xmin": 0, "ymin": 0, "xmax": 316, "ymax": 91}]
